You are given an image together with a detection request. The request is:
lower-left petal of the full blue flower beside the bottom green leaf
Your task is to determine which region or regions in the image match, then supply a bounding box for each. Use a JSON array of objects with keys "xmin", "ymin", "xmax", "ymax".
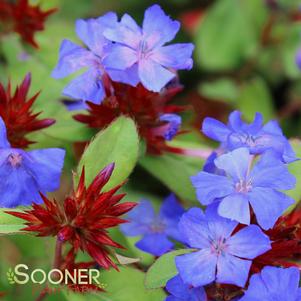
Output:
[{"xmin": 175, "ymin": 249, "xmax": 217, "ymax": 287}]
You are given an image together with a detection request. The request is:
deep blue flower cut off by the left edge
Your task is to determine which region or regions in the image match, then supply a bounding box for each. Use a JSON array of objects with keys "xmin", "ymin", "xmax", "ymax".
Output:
[{"xmin": 0, "ymin": 118, "xmax": 65, "ymax": 208}]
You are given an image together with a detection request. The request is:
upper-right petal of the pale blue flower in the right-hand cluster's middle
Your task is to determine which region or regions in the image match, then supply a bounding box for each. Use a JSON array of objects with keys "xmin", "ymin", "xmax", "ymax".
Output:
[{"xmin": 250, "ymin": 151, "xmax": 296, "ymax": 190}]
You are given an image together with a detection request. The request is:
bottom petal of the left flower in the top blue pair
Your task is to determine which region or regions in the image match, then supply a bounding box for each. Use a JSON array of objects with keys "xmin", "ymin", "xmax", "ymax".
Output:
[{"xmin": 63, "ymin": 69, "xmax": 105, "ymax": 104}]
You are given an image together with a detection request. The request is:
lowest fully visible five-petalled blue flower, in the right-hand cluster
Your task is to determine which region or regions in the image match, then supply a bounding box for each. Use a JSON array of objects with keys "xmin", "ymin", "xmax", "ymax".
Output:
[{"xmin": 175, "ymin": 205, "xmax": 271, "ymax": 287}]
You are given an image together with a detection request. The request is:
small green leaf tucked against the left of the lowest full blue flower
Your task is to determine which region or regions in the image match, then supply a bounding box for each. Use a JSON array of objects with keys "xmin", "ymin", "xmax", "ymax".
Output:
[{"xmin": 145, "ymin": 249, "xmax": 193, "ymax": 289}]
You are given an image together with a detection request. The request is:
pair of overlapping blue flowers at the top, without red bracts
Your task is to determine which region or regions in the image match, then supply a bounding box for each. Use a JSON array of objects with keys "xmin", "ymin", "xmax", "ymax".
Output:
[{"xmin": 52, "ymin": 5, "xmax": 194, "ymax": 104}]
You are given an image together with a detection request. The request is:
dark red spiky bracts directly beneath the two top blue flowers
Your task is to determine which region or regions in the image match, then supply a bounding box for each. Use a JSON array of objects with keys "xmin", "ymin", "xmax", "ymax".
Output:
[{"xmin": 74, "ymin": 82, "xmax": 185, "ymax": 155}]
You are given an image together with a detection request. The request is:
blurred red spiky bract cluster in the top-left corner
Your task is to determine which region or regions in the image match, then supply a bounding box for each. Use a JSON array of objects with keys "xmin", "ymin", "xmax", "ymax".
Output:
[{"xmin": 0, "ymin": 0, "xmax": 57, "ymax": 48}]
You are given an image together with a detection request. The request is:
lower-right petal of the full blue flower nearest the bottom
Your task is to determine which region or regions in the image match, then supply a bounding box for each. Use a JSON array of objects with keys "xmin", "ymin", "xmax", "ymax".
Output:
[{"xmin": 216, "ymin": 253, "xmax": 252, "ymax": 287}]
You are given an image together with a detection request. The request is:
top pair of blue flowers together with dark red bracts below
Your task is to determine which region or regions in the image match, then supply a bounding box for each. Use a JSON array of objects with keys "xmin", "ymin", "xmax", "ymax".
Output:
[{"xmin": 52, "ymin": 5, "xmax": 194, "ymax": 154}]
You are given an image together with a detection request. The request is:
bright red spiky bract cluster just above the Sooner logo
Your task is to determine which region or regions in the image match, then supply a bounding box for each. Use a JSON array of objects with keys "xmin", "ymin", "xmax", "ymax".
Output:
[{"xmin": 10, "ymin": 164, "xmax": 136, "ymax": 269}]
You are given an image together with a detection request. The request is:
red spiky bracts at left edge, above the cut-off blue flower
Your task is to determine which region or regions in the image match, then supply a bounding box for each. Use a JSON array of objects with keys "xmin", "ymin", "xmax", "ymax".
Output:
[{"xmin": 0, "ymin": 74, "xmax": 55, "ymax": 148}]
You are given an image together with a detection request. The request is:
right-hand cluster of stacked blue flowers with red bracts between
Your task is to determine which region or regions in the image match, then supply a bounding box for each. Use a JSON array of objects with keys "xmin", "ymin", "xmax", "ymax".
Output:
[{"xmin": 167, "ymin": 111, "xmax": 300, "ymax": 301}]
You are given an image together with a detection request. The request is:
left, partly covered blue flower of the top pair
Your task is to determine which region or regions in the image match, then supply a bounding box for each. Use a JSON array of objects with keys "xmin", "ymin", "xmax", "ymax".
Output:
[{"xmin": 52, "ymin": 12, "xmax": 139, "ymax": 104}]
